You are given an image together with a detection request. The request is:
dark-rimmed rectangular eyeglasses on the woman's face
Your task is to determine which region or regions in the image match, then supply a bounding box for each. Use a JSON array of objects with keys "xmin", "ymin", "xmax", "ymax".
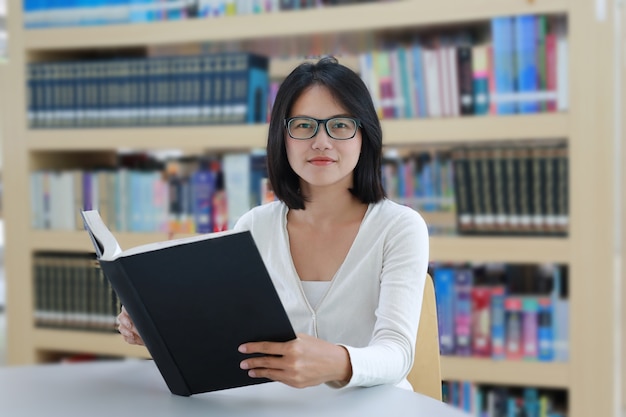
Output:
[{"xmin": 285, "ymin": 117, "xmax": 361, "ymax": 140}]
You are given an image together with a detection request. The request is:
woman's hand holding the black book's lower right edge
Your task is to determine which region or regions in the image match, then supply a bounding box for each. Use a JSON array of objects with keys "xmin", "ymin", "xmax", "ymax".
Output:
[{"xmin": 239, "ymin": 334, "xmax": 352, "ymax": 388}]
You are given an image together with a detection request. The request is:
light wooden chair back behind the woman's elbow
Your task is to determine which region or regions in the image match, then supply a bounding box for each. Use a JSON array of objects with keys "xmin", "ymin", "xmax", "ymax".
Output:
[{"xmin": 407, "ymin": 275, "xmax": 441, "ymax": 401}]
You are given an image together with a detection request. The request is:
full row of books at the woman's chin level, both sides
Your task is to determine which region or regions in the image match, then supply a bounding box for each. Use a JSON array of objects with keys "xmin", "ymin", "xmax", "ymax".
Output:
[{"xmin": 31, "ymin": 143, "xmax": 569, "ymax": 235}]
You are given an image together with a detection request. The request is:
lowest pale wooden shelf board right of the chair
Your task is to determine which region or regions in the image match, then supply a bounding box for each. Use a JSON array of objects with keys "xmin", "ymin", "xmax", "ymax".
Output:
[{"xmin": 441, "ymin": 356, "xmax": 571, "ymax": 388}]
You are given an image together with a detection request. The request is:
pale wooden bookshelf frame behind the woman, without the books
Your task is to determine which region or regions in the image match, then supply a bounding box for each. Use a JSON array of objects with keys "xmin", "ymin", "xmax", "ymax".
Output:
[{"xmin": 2, "ymin": 0, "xmax": 626, "ymax": 417}]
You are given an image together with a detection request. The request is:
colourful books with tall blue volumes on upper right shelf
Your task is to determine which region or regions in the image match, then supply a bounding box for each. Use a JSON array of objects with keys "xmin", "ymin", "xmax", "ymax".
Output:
[{"xmin": 359, "ymin": 15, "xmax": 568, "ymax": 119}]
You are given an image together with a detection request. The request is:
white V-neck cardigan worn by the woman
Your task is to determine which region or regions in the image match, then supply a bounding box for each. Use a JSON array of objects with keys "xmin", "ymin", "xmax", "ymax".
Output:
[{"xmin": 235, "ymin": 199, "xmax": 428, "ymax": 389}]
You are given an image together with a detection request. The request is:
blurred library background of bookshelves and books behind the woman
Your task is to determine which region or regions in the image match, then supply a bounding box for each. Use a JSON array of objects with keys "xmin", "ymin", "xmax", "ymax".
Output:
[{"xmin": 0, "ymin": 0, "xmax": 626, "ymax": 417}]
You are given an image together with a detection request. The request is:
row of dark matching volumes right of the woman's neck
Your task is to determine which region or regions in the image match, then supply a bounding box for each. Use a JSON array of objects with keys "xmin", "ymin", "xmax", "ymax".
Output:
[{"xmin": 452, "ymin": 142, "xmax": 569, "ymax": 235}]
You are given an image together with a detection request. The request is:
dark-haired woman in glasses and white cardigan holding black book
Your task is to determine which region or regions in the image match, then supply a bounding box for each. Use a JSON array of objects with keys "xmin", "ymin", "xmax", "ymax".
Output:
[{"xmin": 118, "ymin": 58, "xmax": 428, "ymax": 389}]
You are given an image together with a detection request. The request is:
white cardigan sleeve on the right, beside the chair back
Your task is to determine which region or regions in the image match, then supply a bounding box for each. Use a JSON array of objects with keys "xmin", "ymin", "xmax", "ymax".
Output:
[{"xmin": 329, "ymin": 211, "xmax": 429, "ymax": 389}]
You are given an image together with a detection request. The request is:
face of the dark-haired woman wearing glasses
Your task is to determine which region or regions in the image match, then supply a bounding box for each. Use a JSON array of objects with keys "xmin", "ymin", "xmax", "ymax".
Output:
[{"xmin": 285, "ymin": 85, "xmax": 363, "ymax": 189}]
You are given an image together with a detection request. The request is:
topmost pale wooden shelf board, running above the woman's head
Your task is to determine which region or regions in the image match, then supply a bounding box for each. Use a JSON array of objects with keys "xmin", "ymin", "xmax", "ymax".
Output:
[{"xmin": 23, "ymin": 0, "xmax": 568, "ymax": 51}]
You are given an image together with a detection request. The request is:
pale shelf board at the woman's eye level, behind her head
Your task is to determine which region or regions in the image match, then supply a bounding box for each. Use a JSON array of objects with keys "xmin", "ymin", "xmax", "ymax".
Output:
[{"xmin": 27, "ymin": 113, "xmax": 569, "ymax": 151}]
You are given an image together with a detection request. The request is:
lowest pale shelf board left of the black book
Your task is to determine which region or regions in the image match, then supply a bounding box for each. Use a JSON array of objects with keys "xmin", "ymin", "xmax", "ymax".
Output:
[{"xmin": 33, "ymin": 329, "xmax": 150, "ymax": 358}]
